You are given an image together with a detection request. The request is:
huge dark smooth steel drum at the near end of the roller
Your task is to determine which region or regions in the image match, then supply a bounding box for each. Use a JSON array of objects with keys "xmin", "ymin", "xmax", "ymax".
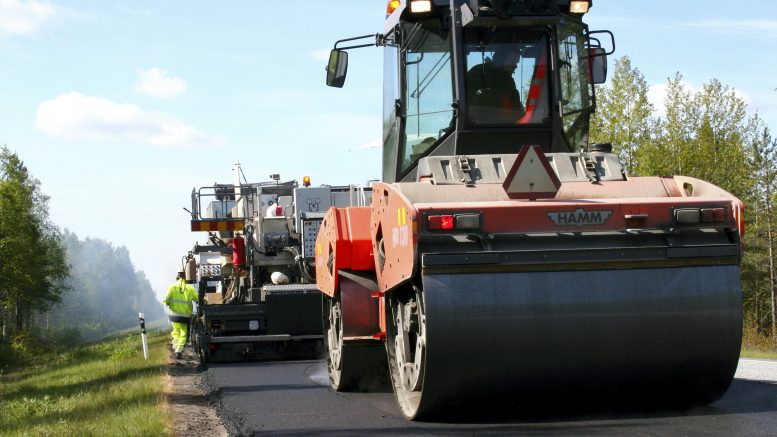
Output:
[{"xmin": 387, "ymin": 265, "xmax": 742, "ymax": 418}]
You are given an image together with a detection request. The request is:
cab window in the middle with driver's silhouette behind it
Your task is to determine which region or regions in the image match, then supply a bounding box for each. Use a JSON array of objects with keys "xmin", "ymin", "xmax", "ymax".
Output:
[{"xmin": 464, "ymin": 28, "xmax": 550, "ymax": 126}]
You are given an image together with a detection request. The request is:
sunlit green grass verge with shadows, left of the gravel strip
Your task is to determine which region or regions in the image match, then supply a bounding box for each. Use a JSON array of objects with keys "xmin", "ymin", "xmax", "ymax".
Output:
[{"xmin": 0, "ymin": 333, "xmax": 168, "ymax": 436}]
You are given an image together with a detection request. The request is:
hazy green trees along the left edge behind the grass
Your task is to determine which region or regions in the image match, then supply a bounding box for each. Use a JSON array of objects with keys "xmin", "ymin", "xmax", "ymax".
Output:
[{"xmin": 0, "ymin": 147, "xmax": 164, "ymax": 348}]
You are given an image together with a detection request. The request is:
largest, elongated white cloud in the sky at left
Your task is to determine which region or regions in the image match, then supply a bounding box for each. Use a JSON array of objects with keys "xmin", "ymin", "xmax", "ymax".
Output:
[{"xmin": 36, "ymin": 92, "xmax": 224, "ymax": 148}]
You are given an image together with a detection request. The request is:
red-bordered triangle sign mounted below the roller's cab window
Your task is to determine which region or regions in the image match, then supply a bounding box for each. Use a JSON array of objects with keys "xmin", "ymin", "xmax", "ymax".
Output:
[{"xmin": 502, "ymin": 146, "xmax": 561, "ymax": 200}]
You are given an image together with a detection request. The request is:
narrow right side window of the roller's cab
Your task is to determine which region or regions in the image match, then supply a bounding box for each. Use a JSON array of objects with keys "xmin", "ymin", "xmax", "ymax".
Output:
[{"xmin": 558, "ymin": 22, "xmax": 593, "ymax": 150}]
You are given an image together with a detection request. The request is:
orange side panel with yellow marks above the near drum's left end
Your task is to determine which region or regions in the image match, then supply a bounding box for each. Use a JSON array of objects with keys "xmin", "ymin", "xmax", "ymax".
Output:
[{"xmin": 370, "ymin": 183, "xmax": 418, "ymax": 292}]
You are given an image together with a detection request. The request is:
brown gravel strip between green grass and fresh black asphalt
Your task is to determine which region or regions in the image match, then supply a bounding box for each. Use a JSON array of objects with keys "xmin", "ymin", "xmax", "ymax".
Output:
[{"xmin": 165, "ymin": 348, "xmax": 229, "ymax": 437}]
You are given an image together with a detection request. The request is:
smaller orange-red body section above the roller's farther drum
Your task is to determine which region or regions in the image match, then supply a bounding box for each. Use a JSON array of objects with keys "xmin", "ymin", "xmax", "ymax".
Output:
[{"xmin": 316, "ymin": 207, "xmax": 374, "ymax": 296}]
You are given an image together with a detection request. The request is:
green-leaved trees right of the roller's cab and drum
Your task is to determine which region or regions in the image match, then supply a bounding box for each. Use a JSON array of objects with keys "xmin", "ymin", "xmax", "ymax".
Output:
[{"xmin": 590, "ymin": 56, "xmax": 777, "ymax": 341}]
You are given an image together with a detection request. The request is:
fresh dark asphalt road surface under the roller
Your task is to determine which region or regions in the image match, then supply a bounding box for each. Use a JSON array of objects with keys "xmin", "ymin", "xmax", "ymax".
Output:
[{"xmin": 204, "ymin": 359, "xmax": 777, "ymax": 436}]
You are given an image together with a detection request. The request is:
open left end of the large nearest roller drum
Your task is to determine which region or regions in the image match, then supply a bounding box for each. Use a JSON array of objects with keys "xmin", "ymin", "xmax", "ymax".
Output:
[{"xmin": 386, "ymin": 286, "xmax": 426, "ymax": 418}]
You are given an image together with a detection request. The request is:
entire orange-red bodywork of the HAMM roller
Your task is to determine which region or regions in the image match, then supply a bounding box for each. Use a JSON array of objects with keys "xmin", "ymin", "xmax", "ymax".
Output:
[{"xmin": 316, "ymin": 172, "xmax": 744, "ymax": 339}]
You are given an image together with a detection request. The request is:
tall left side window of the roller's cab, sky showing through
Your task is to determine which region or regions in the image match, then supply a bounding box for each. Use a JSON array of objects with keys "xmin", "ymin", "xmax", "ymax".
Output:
[{"xmin": 399, "ymin": 21, "xmax": 453, "ymax": 173}]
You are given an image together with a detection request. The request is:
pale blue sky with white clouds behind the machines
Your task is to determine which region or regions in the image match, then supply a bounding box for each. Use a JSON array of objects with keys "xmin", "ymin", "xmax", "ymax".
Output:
[{"xmin": 0, "ymin": 0, "xmax": 777, "ymax": 300}]
